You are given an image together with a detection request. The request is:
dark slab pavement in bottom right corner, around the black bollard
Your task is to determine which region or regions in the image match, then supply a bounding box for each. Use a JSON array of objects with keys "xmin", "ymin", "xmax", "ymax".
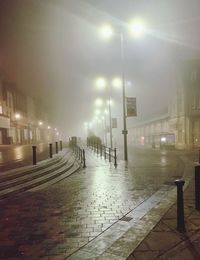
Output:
[{"xmin": 127, "ymin": 169, "xmax": 200, "ymax": 260}]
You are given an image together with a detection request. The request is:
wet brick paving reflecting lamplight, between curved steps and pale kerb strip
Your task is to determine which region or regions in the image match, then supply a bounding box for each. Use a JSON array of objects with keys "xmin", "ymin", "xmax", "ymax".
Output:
[{"xmin": 0, "ymin": 146, "xmax": 185, "ymax": 259}]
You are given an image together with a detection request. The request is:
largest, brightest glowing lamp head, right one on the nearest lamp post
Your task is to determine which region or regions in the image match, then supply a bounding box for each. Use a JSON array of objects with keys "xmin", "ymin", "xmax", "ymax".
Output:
[{"xmin": 129, "ymin": 18, "xmax": 146, "ymax": 38}]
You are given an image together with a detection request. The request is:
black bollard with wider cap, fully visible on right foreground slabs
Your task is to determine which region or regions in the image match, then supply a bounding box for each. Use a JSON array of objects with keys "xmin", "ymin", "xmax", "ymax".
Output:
[{"xmin": 174, "ymin": 180, "xmax": 185, "ymax": 232}]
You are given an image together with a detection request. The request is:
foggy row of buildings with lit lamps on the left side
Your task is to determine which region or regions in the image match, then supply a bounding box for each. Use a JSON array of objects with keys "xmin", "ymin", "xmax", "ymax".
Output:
[{"xmin": 0, "ymin": 79, "xmax": 59, "ymax": 144}]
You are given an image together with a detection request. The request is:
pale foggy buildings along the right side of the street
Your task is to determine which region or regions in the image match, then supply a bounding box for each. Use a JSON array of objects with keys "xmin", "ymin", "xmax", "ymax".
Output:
[{"xmin": 129, "ymin": 60, "xmax": 200, "ymax": 149}]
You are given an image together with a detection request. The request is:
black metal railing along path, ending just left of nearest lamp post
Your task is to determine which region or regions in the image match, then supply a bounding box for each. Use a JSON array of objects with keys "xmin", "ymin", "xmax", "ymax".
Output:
[{"xmin": 87, "ymin": 142, "xmax": 117, "ymax": 168}]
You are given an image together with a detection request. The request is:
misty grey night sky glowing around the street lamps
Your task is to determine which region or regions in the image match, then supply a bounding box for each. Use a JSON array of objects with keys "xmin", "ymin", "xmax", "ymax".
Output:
[{"xmin": 0, "ymin": 0, "xmax": 200, "ymax": 138}]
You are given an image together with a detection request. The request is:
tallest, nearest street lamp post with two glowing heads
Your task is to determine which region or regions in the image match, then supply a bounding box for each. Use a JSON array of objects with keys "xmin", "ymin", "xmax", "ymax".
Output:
[{"xmin": 100, "ymin": 18, "xmax": 146, "ymax": 161}]
